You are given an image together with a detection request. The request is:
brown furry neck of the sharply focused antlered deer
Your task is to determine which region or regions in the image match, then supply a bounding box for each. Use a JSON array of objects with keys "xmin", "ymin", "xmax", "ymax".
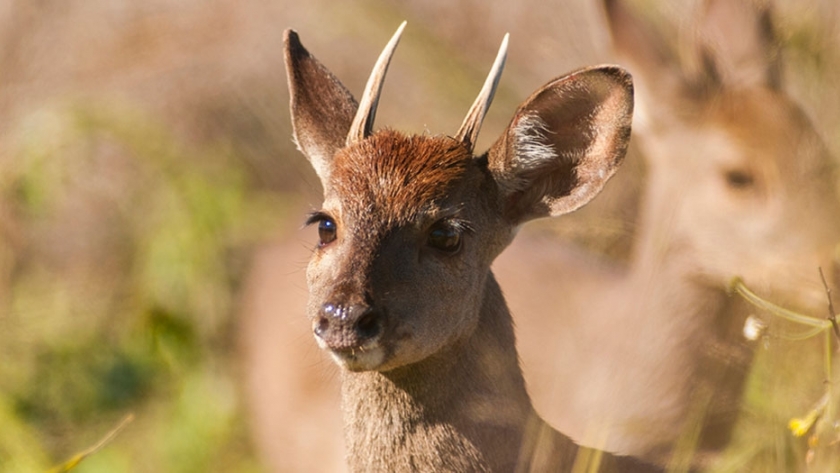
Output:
[{"xmin": 342, "ymin": 273, "xmax": 575, "ymax": 471}]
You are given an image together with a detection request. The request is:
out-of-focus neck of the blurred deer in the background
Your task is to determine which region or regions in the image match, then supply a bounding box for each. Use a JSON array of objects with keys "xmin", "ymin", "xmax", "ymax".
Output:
[{"xmin": 604, "ymin": 172, "xmax": 754, "ymax": 451}]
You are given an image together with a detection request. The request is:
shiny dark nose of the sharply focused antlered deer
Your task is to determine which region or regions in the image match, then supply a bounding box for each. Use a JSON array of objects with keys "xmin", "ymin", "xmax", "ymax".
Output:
[{"xmin": 313, "ymin": 303, "xmax": 385, "ymax": 350}]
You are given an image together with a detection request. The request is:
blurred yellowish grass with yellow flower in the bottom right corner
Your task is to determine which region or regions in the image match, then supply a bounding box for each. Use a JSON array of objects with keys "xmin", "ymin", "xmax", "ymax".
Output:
[{"xmin": 713, "ymin": 280, "xmax": 840, "ymax": 472}]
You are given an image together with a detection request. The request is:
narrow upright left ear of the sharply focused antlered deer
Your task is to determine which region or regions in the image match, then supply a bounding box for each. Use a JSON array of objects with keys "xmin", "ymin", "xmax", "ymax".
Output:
[{"xmin": 285, "ymin": 30, "xmax": 358, "ymax": 184}]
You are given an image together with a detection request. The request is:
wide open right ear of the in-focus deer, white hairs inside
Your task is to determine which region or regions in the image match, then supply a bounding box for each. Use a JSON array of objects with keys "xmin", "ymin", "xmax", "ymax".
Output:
[{"xmin": 488, "ymin": 66, "xmax": 633, "ymax": 223}]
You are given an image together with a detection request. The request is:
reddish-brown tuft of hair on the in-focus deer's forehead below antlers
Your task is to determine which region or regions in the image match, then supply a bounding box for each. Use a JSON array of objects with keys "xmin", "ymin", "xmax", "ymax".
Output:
[{"xmin": 330, "ymin": 129, "xmax": 473, "ymax": 223}]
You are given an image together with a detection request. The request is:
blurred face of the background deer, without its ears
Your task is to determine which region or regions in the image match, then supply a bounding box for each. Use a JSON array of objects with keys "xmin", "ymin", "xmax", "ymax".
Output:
[{"xmin": 640, "ymin": 89, "xmax": 840, "ymax": 301}]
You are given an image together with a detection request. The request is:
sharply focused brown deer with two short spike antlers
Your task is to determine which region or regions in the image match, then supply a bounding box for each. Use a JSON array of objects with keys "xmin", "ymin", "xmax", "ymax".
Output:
[{"xmin": 286, "ymin": 23, "xmax": 668, "ymax": 471}]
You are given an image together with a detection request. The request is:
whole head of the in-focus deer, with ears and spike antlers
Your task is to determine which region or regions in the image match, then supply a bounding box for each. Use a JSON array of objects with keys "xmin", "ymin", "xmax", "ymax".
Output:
[{"xmin": 286, "ymin": 24, "xmax": 633, "ymax": 371}]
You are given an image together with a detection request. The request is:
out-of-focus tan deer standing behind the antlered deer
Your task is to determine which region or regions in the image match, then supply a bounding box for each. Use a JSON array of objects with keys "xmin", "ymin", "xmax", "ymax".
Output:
[{"xmin": 495, "ymin": 0, "xmax": 840, "ymax": 461}]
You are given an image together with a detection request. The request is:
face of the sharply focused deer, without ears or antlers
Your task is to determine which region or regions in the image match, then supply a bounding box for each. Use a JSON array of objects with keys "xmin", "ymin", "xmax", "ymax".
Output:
[{"xmin": 308, "ymin": 131, "xmax": 510, "ymax": 371}]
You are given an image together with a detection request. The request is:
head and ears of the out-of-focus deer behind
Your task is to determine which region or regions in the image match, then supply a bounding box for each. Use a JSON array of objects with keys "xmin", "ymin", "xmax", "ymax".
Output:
[{"xmin": 607, "ymin": 0, "xmax": 840, "ymax": 303}]
